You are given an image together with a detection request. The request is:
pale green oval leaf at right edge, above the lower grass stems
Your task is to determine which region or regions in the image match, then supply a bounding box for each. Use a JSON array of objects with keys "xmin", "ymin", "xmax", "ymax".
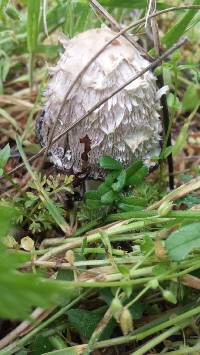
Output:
[{"xmin": 165, "ymin": 222, "xmax": 200, "ymax": 261}]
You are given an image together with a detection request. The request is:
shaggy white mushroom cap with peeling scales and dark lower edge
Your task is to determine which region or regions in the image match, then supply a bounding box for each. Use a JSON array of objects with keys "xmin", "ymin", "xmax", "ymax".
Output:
[{"xmin": 37, "ymin": 28, "xmax": 165, "ymax": 179}]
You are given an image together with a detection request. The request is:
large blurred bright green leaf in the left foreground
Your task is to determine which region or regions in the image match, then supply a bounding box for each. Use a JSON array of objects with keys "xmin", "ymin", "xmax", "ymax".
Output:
[{"xmin": 0, "ymin": 247, "xmax": 73, "ymax": 319}]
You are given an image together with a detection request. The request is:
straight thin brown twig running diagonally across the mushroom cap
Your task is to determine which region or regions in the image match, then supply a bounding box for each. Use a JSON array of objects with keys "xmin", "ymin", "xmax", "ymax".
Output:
[{"xmin": 0, "ymin": 35, "xmax": 187, "ymax": 179}]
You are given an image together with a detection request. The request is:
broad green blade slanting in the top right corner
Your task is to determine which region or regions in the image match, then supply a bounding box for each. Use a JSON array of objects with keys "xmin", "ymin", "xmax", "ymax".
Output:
[{"xmin": 162, "ymin": 0, "xmax": 200, "ymax": 47}]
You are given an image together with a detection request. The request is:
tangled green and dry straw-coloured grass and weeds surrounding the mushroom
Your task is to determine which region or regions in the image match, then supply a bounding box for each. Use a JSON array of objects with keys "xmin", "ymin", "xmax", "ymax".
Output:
[{"xmin": 0, "ymin": 0, "xmax": 200, "ymax": 355}]
